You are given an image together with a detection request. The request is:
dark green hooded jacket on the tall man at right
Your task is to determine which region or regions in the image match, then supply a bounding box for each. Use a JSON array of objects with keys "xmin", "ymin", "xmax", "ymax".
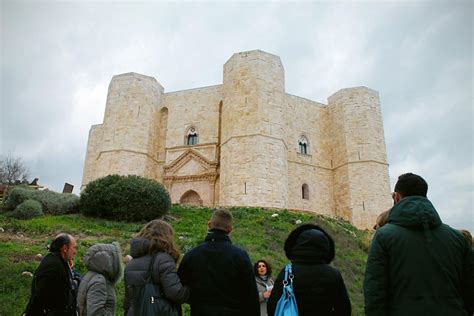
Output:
[{"xmin": 364, "ymin": 196, "xmax": 474, "ymax": 316}]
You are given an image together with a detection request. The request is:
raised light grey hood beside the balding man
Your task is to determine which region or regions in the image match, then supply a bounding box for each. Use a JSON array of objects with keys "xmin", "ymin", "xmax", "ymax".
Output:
[{"xmin": 84, "ymin": 241, "xmax": 123, "ymax": 285}]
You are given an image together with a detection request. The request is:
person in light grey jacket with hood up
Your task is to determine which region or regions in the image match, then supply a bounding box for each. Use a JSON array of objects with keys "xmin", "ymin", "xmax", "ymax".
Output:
[{"xmin": 77, "ymin": 242, "xmax": 123, "ymax": 316}]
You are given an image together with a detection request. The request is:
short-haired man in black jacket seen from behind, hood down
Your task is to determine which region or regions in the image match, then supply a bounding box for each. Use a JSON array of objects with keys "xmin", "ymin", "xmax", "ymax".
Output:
[{"xmin": 178, "ymin": 210, "xmax": 260, "ymax": 316}]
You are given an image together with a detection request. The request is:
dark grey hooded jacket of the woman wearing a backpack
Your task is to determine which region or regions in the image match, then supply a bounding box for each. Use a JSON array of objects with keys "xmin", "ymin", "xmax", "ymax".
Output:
[{"xmin": 124, "ymin": 238, "xmax": 189, "ymax": 316}]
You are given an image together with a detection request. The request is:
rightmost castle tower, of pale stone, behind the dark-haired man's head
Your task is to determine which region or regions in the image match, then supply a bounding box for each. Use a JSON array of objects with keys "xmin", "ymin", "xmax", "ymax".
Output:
[{"xmin": 328, "ymin": 87, "xmax": 392, "ymax": 228}]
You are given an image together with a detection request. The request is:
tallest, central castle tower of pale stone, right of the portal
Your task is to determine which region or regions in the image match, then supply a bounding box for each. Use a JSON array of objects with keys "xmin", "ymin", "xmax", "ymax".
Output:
[{"xmin": 219, "ymin": 50, "xmax": 288, "ymax": 208}]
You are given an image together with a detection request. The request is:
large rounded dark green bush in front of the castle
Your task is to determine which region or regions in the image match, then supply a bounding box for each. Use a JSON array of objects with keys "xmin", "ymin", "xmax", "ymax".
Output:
[{"xmin": 80, "ymin": 175, "xmax": 171, "ymax": 222}]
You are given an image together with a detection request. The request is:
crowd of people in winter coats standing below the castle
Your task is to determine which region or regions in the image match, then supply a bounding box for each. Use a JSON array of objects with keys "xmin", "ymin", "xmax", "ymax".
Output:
[{"xmin": 25, "ymin": 173, "xmax": 474, "ymax": 316}]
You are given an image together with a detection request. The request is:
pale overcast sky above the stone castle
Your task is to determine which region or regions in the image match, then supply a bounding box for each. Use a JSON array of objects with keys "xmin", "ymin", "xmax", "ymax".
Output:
[{"xmin": 0, "ymin": 0, "xmax": 474, "ymax": 231}]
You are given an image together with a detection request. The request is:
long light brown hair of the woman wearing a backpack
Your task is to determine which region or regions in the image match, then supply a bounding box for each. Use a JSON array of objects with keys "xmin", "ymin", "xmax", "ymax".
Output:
[{"xmin": 137, "ymin": 219, "xmax": 180, "ymax": 262}]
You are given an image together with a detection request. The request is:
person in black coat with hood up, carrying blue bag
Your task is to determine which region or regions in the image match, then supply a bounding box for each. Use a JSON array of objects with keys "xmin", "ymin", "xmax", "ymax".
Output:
[{"xmin": 267, "ymin": 224, "xmax": 351, "ymax": 316}]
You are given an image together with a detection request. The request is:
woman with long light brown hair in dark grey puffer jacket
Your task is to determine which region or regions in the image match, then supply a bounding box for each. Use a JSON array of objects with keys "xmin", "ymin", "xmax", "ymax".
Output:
[{"xmin": 124, "ymin": 219, "xmax": 189, "ymax": 316}]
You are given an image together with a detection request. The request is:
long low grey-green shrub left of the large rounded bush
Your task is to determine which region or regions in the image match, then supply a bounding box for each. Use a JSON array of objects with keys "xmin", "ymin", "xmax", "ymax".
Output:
[{"xmin": 5, "ymin": 187, "xmax": 79, "ymax": 215}]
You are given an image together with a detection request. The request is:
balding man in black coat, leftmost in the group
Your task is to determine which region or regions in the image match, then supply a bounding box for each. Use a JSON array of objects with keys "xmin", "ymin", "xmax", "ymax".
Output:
[{"xmin": 25, "ymin": 234, "xmax": 77, "ymax": 316}]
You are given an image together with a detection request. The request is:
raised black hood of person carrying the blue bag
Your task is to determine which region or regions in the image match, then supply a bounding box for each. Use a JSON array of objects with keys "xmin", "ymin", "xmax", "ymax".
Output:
[{"xmin": 285, "ymin": 224, "xmax": 335, "ymax": 264}]
